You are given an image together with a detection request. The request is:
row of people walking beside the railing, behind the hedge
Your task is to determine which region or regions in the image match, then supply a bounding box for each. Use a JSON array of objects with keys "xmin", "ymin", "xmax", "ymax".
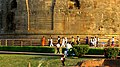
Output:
[{"xmin": 42, "ymin": 36, "xmax": 114, "ymax": 47}]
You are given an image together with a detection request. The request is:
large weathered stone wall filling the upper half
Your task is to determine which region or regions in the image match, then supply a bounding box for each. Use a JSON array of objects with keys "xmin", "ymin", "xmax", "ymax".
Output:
[{"xmin": 0, "ymin": 0, "xmax": 120, "ymax": 34}]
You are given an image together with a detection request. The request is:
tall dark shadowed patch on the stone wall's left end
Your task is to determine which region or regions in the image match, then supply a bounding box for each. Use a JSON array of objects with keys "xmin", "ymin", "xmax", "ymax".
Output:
[{"xmin": 6, "ymin": 0, "xmax": 17, "ymax": 32}]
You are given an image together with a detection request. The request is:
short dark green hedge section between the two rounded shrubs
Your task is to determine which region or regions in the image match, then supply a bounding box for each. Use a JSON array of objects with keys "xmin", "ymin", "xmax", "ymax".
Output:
[{"xmin": 87, "ymin": 48, "xmax": 104, "ymax": 55}]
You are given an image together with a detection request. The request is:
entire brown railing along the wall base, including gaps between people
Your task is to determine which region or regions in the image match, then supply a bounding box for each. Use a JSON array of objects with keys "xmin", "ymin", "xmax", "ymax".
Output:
[{"xmin": 0, "ymin": 38, "xmax": 119, "ymax": 46}]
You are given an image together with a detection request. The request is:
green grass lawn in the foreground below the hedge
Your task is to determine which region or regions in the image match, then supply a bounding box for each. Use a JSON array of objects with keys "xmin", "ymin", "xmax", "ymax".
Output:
[{"xmin": 0, "ymin": 54, "xmax": 101, "ymax": 67}]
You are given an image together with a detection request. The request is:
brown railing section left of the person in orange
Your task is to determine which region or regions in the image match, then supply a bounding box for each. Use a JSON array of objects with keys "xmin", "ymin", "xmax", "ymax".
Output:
[{"xmin": 0, "ymin": 39, "xmax": 41, "ymax": 46}]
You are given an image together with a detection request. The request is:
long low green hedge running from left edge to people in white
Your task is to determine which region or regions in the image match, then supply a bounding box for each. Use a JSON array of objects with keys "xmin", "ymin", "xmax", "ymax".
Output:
[{"xmin": 0, "ymin": 46, "xmax": 55, "ymax": 53}]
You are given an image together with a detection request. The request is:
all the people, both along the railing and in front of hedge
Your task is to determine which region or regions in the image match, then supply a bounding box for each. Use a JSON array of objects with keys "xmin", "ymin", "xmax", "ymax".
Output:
[{"xmin": 42, "ymin": 36, "xmax": 114, "ymax": 66}]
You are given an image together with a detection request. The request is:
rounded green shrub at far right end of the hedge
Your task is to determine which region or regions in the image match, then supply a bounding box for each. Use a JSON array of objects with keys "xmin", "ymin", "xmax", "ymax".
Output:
[{"xmin": 104, "ymin": 48, "xmax": 119, "ymax": 58}]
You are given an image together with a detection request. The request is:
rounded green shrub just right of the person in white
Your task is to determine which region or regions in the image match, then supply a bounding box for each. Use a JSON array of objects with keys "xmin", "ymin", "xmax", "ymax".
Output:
[{"xmin": 73, "ymin": 45, "xmax": 89, "ymax": 57}]
